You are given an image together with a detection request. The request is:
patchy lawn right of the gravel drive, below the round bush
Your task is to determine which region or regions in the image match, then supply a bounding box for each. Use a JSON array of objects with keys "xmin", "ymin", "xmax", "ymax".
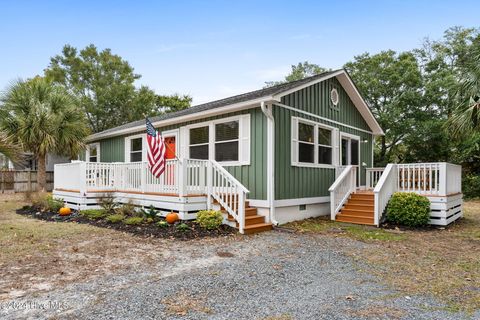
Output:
[{"xmin": 285, "ymin": 201, "xmax": 480, "ymax": 312}]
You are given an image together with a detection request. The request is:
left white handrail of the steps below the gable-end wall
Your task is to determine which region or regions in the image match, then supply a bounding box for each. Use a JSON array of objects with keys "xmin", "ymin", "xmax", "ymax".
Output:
[{"xmin": 328, "ymin": 165, "xmax": 357, "ymax": 220}]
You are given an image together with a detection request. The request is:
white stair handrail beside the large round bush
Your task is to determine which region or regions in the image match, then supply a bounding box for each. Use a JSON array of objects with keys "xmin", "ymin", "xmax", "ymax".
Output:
[{"xmin": 373, "ymin": 163, "xmax": 398, "ymax": 227}]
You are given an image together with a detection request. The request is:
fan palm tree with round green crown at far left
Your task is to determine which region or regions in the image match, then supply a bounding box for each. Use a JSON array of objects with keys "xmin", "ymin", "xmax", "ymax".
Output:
[{"xmin": 0, "ymin": 77, "xmax": 89, "ymax": 191}]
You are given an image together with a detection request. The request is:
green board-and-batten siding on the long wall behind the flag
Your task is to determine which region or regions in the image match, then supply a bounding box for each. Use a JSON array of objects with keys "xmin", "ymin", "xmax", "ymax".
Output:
[{"xmin": 83, "ymin": 108, "xmax": 267, "ymax": 200}]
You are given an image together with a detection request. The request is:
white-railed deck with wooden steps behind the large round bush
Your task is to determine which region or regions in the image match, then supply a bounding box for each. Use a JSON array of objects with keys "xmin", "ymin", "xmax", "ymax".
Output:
[{"xmin": 329, "ymin": 162, "xmax": 463, "ymax": 226}]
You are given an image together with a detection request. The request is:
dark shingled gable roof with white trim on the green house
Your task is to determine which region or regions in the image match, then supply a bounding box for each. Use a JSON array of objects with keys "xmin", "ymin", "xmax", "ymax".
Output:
[{"xmin": 87, "ymin": 69, "xmax": 383, "ymax": 141}]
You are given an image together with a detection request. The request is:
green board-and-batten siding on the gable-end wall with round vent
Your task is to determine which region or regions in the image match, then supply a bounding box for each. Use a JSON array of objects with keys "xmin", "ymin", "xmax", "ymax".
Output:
[{"xmin": 273, "ymin": 79, "xmax": 373, "ymax": 200}]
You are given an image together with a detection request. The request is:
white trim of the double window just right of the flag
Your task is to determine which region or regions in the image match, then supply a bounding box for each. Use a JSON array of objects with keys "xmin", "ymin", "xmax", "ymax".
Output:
[{"xmin": 184, "ymin": 114, "xmax": 251, "ymax": 167}]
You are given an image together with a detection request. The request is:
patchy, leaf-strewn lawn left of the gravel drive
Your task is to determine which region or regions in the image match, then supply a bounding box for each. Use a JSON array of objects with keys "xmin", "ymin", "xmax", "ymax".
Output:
[{"xmin": 0, "ymin": 195, "xmax": 167, "ymax": 301}]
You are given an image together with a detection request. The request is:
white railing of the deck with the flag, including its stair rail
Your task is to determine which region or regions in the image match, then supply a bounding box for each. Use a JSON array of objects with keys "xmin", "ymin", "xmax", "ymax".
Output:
[{"xmin": 54, "ymin": 159, "xmax": 249, "ymax": 233}]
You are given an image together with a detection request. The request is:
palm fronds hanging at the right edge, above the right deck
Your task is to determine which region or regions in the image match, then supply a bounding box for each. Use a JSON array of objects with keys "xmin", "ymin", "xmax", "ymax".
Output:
[{"xmin": 449, "ymin": 45, "xmax": 480, "ymax": 135}]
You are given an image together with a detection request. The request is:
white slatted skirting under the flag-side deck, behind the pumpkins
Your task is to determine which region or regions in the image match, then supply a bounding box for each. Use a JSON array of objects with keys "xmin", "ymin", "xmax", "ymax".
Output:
[{"xmin": 52, "ymin": 190, "xmax": 207, "ymax": 220}]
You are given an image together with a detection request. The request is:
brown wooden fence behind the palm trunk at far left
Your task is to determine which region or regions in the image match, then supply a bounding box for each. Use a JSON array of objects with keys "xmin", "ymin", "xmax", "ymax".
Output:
[{"xmin": 0, "ymin": 170, "xmax": 53, "ymax": 193}]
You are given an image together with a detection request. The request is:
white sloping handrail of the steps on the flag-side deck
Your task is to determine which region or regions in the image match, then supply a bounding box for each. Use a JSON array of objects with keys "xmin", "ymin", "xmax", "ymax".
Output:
[{"xmin": 207, "ymin": 160, "xmax": 250, "ymax": 234}]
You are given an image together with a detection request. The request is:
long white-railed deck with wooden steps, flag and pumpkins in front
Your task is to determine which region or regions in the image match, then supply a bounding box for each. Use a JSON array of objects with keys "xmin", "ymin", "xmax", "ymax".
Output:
[{"xmin": 53, "ymin": 159, "xmax": 272, "ymax": 233}]
